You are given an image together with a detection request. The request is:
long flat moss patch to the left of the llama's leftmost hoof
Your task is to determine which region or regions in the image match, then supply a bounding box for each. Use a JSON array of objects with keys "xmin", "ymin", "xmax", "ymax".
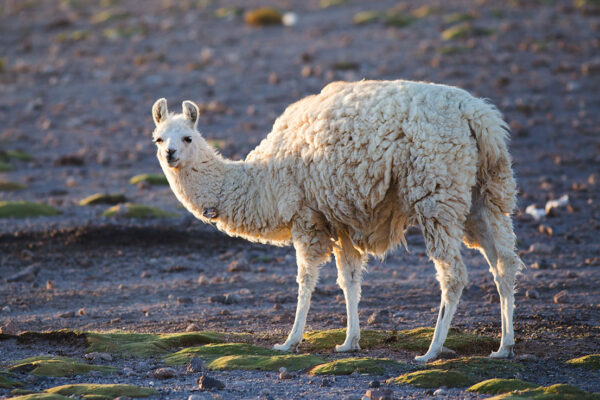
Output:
[{"xmin": 87, "ymin": 332, "xmax": 223, "ymax": 357}]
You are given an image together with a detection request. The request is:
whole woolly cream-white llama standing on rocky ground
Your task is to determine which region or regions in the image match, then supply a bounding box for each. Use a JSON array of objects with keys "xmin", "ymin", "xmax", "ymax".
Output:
[{"xmin": 152, "ymin": 80, "xmax": 522, "ymax": 362}]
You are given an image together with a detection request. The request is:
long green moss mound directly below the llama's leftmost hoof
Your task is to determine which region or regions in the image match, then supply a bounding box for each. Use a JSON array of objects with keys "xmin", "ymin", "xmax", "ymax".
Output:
[{"xmin": 207, "ymin": 354, "xmax": 325, "ymax": 371}]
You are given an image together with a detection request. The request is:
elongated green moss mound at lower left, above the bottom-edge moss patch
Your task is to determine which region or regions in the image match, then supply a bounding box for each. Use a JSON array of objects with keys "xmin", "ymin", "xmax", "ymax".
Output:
[{"xmin": 10, "ymin": 356, "xmax": 118, "ymax": 376}]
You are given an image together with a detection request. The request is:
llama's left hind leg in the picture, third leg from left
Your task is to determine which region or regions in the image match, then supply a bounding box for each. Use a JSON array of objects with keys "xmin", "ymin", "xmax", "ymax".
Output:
[{"xmin": 415, "ymin": 219, "xmax": 467, "ymax": 362}]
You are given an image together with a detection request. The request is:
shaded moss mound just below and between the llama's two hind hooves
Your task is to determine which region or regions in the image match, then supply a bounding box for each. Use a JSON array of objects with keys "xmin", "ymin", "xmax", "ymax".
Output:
[{"xmin": 428, "ymin": 357, "xmax": 525, "ymax": 380}]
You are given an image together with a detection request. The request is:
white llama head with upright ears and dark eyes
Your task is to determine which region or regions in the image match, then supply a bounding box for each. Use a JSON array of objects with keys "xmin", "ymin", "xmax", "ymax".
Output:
[{"xmin": 152, "ymin": 98, "xmax": 210, "ymax": 168}]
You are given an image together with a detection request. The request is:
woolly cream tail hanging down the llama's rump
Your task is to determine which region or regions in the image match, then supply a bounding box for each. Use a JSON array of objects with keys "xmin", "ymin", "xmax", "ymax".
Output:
[{"xmin": 461, "ymin": 99, "xmax": 517, "ymax": 215}]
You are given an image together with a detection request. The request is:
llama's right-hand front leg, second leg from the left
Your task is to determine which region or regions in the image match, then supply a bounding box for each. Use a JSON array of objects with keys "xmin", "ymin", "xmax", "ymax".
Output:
[{"xmin": 333, "ymin": 235, "xmax": 366, "ymax": 352}]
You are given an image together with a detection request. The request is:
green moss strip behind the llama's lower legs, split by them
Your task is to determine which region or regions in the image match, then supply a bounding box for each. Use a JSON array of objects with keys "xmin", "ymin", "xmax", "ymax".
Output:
[{"xmin": 304, "ymin": 328, "xmax": 498, "ymax": 354}]
